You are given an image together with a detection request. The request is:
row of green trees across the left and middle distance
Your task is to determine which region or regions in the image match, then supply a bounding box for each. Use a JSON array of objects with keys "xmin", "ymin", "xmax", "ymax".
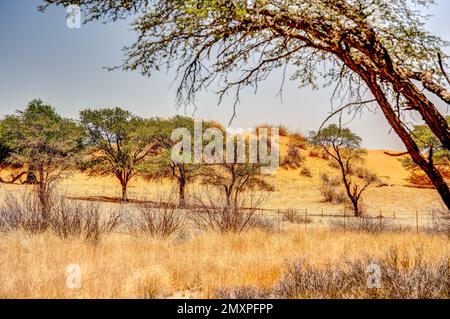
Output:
[{"xmin": 0, "ymin": 99, "xmax": 270, "ymax": 207}]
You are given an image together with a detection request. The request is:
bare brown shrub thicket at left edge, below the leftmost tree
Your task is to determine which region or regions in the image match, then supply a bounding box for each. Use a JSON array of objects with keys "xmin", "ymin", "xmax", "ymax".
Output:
[{"xmin": 0, "ymin": 193, "xmax": 121, "ymax": 241}]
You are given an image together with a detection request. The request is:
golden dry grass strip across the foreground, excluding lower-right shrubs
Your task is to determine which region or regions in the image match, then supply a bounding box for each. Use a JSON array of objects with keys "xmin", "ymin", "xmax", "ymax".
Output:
[{"xmin": 0, "ymin": 226, "xmax": 450, "ymax": 298}]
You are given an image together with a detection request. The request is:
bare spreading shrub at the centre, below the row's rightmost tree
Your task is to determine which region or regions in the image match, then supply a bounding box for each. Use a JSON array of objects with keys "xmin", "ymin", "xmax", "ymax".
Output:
[{"xmin": 188, "ymin": 190, "xmax": 274, "ymax": 233}]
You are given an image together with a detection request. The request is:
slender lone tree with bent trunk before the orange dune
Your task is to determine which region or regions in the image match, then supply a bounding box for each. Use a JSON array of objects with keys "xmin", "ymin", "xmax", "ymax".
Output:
[{"xmin": 311, "ymin": 124, "xmax": 379, "ymax": 217}]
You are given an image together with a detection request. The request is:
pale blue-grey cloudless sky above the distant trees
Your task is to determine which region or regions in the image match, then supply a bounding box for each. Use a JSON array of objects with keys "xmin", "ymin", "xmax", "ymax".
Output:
[{"xmin": 0, "ymin": 0, "xmax": 450, "ymax": 149}]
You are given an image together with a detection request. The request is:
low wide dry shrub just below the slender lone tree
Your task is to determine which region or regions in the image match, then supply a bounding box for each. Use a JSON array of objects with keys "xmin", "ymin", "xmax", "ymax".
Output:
[{"xmin": 329, "ymin": 216, "xmax": 396, "ymax": 234}]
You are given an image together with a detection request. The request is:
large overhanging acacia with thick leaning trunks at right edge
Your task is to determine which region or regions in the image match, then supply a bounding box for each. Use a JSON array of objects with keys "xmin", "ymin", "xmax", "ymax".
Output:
[{"xmin": 41, "ymin": 0, "xmax": 450, "ymax": 208}]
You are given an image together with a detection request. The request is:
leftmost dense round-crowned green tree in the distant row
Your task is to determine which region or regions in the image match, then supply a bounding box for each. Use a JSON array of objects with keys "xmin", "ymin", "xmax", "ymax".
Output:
[{"xmin": 0, "ymin": 100, "xmax": 82, "ymax": 210}]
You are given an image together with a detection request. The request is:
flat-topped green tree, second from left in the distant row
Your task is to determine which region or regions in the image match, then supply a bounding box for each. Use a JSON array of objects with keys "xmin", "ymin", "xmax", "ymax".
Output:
[{"xmin": 80, "ymin": 108, "xmax": 156, "ymax": 202}]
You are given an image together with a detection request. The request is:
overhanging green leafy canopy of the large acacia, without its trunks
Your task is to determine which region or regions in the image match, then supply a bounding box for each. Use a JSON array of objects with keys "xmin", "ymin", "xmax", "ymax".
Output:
[{"xmin": 41, "ymin": 0, "xmax": 446, "ymax": 100}]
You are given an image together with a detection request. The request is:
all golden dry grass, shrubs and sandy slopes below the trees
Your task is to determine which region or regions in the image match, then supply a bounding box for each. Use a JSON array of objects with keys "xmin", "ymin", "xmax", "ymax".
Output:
[{"xmin": 0, "ymin": 146, "xmax": 450, "ymax": 298}]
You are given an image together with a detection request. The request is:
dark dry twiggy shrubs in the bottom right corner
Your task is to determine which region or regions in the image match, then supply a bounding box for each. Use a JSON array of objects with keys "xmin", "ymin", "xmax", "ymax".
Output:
[{"xmin": 274, "ymin": 250, "xmax": 450, "ymax": 299}]
